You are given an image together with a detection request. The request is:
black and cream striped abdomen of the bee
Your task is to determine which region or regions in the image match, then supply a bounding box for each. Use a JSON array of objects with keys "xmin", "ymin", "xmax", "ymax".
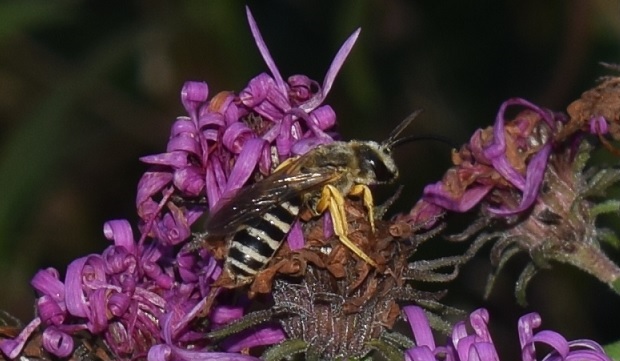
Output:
[{"xmin": 224, "ymin": 199, "xmax": 300, "ymax": 284}]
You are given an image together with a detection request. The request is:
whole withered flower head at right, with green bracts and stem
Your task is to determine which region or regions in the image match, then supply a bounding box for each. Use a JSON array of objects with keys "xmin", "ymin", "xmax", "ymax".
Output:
[{"xmin": 401, "ymin": 94, "xmax": 620, "ymax": 304}]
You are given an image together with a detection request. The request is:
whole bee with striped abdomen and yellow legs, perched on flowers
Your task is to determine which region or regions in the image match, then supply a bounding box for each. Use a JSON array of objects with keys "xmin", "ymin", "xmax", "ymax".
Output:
[{"xmin": 196, "ymin": 111, "xmax": 420, "ymax": 287}]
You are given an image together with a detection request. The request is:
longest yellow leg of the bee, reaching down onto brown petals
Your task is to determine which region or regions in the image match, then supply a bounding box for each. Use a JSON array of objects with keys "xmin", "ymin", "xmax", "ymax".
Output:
[{"xmin": 316, "ymin": 185, "xmax": 377, "ymax": 267}]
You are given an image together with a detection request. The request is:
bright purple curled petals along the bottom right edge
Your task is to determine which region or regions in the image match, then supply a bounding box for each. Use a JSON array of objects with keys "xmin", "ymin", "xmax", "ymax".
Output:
[{"xmin": 403, "ymin": 306, "xmax": 611, "ymax": 361}]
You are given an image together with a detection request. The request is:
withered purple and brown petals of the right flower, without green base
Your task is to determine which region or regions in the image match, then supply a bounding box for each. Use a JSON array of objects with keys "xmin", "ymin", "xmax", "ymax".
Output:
[{"xmin": 404, "ymin": 98, "xmax": 566, "ymax": 228}]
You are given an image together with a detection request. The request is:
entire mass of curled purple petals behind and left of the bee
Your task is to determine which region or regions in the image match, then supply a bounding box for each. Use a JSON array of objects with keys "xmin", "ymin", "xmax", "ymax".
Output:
[{"xmin": 0, "ymin": 5, "xmax": 359, "ymax": 360}]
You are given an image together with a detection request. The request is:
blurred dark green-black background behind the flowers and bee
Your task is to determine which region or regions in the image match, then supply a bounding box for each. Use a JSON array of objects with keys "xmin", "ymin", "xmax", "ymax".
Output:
[{"xmin": 0, "ymin": 0, "xmax": 620, "ymax": 352}]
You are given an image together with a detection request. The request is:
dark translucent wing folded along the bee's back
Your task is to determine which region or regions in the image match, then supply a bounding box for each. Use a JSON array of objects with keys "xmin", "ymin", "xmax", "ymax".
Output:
[{"xmin": 205, "ymin": 162, "xmax": 340, "ymax": 236}]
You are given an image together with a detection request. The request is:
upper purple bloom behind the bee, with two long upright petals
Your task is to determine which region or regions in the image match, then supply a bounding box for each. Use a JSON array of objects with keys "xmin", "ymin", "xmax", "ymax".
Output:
[{"xmin": 136, "ymin": 10, "xmax": 359, "ymax": 249}]
